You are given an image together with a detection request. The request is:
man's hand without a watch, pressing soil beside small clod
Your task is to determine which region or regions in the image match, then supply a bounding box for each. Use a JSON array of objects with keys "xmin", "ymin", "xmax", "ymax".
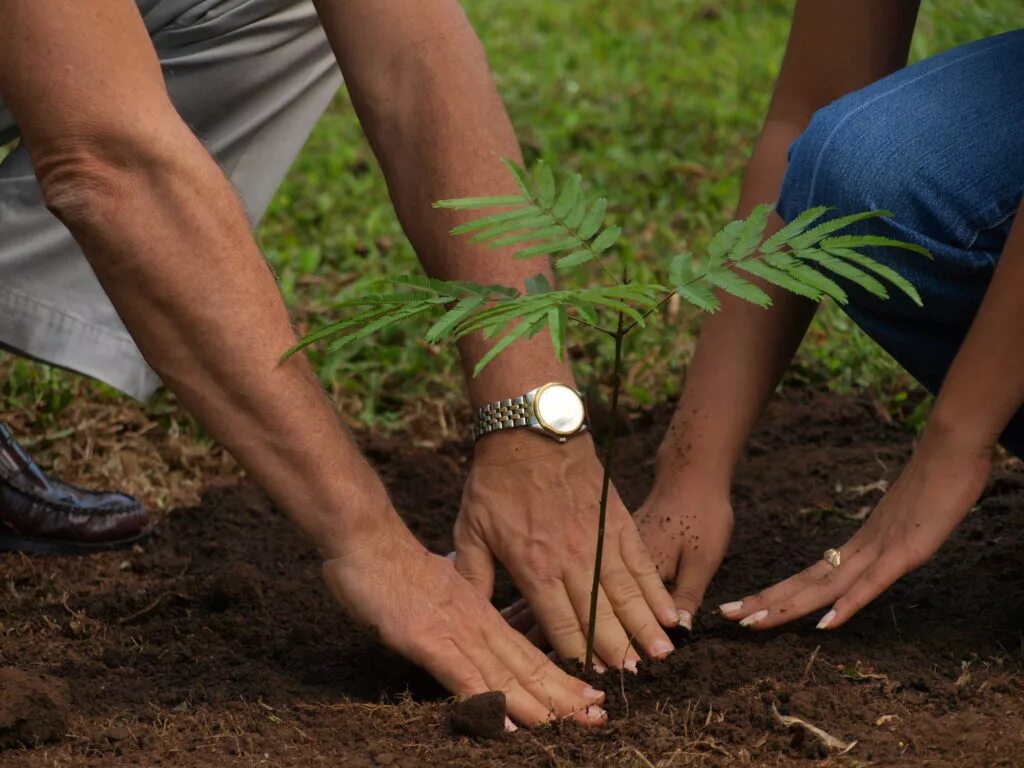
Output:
[{"xmin": 324, "ymin": 511, "xmax": 606, "ymax": 726}]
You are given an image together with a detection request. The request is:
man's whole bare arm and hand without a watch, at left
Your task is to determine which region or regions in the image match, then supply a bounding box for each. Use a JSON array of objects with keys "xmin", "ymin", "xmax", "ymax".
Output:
[{"xmin": 0, "ymin": 0, "xmax": 603, "ymax": 723}]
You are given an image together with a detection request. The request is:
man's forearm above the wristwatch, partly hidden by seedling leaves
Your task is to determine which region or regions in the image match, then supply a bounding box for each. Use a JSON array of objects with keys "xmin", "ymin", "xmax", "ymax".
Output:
[{"xmin": 318, "ymin": 0, "xmax": 572, "ymax": 406}]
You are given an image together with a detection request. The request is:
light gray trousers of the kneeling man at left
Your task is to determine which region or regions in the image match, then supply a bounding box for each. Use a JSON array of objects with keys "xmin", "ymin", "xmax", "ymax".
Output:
[{"xmin": 0, "ymin": 0, "xmax": 341, "ymax": 399}]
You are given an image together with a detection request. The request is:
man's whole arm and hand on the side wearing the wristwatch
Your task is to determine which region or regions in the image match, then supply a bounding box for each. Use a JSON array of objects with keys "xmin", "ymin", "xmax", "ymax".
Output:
[{"xmin": 316, "ymin": 0, "xmax": 679, "ymax": 668}]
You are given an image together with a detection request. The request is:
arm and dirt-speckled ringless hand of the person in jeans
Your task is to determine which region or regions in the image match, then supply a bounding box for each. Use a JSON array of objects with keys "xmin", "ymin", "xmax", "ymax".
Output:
[{"xmin": 638, "ymin": 0, "xmax": 918, "ymax": 611}]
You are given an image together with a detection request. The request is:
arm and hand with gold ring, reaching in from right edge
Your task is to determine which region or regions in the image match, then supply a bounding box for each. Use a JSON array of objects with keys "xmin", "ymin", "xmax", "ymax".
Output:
[{"xmin": 725, "ymin": 205, "xmax": 1024, "ymax": 630}]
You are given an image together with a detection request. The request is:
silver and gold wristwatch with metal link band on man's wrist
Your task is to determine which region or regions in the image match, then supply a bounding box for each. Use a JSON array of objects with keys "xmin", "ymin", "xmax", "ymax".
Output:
[{"xmin": 473, "ymin": 382, "xmax": 587, "ymax": 442}]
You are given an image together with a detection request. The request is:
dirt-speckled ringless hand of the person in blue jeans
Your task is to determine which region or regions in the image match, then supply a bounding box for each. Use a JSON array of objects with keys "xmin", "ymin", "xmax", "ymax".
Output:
[{"xmin": 636, "ymin": 482, "xmax": 733, "ymax": 629}]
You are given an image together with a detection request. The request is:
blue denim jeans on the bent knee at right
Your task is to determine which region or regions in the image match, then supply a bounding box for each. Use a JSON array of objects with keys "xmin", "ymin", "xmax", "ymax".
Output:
[{"xmin": 778, "ymin": 30, "xmax": 1024, "ymax": 456}]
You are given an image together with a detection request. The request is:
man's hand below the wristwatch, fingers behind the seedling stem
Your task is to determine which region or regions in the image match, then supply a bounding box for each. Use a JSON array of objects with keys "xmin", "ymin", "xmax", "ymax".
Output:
[{"xmin": 455, "ymin": 430, "xmax": 679, "ymax": 671}]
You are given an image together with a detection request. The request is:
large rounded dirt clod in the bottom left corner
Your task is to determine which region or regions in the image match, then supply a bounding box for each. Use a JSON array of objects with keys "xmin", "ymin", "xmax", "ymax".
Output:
[{"xmin": 0, "ymin": 668, "xmax": 69, "ymax": 750}]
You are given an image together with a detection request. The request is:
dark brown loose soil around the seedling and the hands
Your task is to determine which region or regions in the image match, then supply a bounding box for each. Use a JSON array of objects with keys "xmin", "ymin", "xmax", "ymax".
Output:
[{"xmin": 0, "ymin": 391, "xmax": 1024, "ymax": 768}]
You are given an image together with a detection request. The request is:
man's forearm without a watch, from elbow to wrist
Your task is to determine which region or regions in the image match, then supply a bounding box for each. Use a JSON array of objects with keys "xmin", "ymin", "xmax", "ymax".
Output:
[{"xmin": 51, "ymin": 135, "xmax": 395, "ymax": 554}]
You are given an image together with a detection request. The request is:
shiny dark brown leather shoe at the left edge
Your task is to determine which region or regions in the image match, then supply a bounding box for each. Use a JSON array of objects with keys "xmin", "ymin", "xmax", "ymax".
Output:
[{"xmin": 0, "ymin": 424, "xmax": 150, "ymax": 555}]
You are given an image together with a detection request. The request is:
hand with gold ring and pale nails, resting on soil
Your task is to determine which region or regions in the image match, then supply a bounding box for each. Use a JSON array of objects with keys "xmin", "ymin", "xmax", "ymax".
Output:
[{"xmin": 720, "ymin": 427, "xmax": 992, "ymax": 630}]
